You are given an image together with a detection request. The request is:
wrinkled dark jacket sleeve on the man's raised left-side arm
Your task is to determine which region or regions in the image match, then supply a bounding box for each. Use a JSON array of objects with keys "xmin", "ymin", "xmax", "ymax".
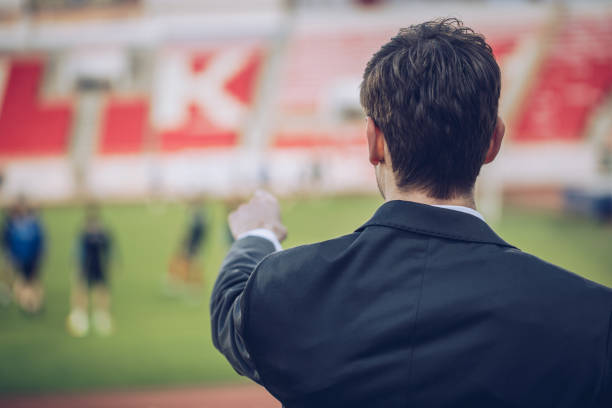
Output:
[{"xmin": 210, "ymin": 236, "xmax": 274, "ymax": 383}]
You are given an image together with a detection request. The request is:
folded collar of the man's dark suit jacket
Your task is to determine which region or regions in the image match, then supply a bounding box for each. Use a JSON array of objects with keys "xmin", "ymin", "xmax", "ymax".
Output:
[{"xmin": 357, "ymin": 200, "xmax": 515, "ymax": 248}]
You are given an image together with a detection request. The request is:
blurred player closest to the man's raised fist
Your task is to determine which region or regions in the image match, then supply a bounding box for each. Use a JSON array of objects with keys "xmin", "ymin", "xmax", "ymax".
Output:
[{"xmin": 168, "ymin": 202, "xmax": 208, "ymax": 293}]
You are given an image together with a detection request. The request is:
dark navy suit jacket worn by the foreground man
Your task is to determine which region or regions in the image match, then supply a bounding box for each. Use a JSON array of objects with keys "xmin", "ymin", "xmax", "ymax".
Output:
[{"xmin": 211, "ymin": 201, "xmax": 612, "ymax": 408}]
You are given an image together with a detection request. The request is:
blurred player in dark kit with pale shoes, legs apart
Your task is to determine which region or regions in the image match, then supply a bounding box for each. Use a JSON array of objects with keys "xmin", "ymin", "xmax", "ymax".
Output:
[{"xmin": 67, "ymin": 206, "xmax": 113, "ymax": 337}]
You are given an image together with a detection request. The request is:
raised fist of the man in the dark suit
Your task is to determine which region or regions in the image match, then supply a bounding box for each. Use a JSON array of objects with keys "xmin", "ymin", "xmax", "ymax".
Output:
[{"xmin": 229, "ymin": 190, "xmax": 287, "ymax": 242}]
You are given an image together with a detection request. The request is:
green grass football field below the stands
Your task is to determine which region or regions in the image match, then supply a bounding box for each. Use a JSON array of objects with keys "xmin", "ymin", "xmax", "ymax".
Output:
[{"xmin": 0, "ymin": 197, "xmax": 612, "ymax": 393}]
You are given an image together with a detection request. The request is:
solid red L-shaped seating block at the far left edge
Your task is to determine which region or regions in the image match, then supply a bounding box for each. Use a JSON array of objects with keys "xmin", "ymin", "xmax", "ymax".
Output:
[{"xmin": 0, "ymin": 59, "xmax": 72, "ymax": 158}]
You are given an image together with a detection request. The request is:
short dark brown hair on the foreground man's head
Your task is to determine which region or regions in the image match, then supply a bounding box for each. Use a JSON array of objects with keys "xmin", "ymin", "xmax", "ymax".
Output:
[{"xmin": 361, "ymin": 18, "xmax": 501, "ymax": 199}]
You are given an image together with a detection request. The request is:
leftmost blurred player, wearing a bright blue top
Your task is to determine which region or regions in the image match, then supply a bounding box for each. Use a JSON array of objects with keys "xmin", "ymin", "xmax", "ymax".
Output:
[{"xmin": 2, "ymin": 197, "xmax": 45, "ymax": 313}]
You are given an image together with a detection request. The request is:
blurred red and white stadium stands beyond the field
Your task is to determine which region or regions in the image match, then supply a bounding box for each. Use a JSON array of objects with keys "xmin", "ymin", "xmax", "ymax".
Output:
[{"xmin": 0, "ymin": 0, "xmax": 612, "ymax": 199}]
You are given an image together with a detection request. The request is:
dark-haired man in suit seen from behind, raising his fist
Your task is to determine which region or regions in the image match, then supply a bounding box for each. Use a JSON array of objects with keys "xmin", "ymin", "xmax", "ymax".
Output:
[{"xmin": 211, "ymin": 20, "xmax": 612, "ymax": 408}]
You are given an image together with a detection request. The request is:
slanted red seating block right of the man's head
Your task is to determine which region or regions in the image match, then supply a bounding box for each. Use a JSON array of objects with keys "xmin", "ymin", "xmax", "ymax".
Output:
[{"xmin": 514, "ymin": 15, "xmax": 612, "ymax": 142}]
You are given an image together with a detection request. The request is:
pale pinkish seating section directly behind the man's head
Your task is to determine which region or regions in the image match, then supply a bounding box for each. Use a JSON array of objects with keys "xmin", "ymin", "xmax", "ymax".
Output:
[{"xmin": 272, "ymin": 27, "xmax": 517, "ymax": 149}]
